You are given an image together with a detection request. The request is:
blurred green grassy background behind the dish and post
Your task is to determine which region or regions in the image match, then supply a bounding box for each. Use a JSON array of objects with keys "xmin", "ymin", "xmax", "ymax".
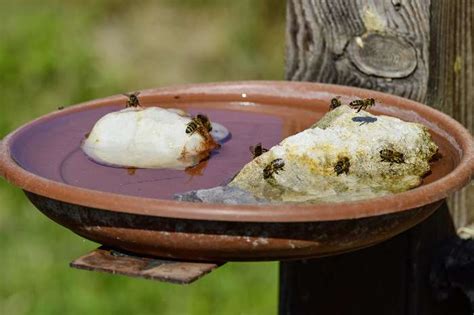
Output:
[{"xmin": 0, "ymin": 0, "xmax": 285, "ymax": 315}]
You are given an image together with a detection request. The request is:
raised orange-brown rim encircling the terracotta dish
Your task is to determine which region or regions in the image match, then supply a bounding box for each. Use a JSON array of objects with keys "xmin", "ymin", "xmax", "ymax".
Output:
[{"xmin": 0, "ymin": 81, "xmax": 474, "ymax": 222}]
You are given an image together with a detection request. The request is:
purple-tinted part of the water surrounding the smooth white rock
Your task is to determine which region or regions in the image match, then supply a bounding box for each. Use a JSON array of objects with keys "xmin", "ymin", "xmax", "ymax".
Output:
[{"xmin": 12, "ymin": 105, "xmax": 283, "ymax": 199}]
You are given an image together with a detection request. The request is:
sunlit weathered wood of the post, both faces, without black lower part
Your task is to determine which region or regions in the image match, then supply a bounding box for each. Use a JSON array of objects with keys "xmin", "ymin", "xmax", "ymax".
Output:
[{"xmin": 286, "ymin": 0, "xmax": 474, "ymax": 231}]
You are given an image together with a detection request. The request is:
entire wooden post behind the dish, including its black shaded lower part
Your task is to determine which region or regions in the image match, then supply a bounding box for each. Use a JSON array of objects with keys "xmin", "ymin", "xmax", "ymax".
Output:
[{"xmin": 280, "ymin": 0, "xmax": 474, "ymax": 315}]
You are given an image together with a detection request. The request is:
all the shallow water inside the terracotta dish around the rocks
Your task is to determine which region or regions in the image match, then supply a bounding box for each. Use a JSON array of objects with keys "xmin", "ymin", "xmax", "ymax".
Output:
[{"xmin": 11, "ymin": 102, "xmax": 458, "ymax": 199}]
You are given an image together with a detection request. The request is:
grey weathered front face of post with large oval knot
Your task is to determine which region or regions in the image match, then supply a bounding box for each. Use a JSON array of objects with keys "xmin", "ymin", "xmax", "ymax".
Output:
[{"xmin": 286, "ymin": 0, "xmax": 429, "ymax": 101}]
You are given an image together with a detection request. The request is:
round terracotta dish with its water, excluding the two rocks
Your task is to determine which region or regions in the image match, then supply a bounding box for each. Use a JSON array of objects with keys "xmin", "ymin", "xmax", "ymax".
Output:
[{"xmin": 0, "ymin": 82, "xmax": 474, "ymax": 260}]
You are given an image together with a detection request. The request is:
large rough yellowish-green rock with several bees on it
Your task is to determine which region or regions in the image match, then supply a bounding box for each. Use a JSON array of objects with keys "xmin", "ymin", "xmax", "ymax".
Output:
[{"xmin": 228, "ymin": 105, "xmax": 438, "ymax": 203}]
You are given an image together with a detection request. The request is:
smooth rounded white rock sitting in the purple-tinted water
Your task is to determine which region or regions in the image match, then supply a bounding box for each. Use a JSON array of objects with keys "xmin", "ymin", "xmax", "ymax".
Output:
[{"xmin": 82, "ymin": 107, "xmax": 218, "ymax": 169}]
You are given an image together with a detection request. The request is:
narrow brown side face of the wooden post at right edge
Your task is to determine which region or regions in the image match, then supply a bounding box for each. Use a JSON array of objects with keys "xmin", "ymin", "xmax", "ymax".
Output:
[{"xmin": 427, "ymin": 0, "xmax": 474, "ymax": 235}]
